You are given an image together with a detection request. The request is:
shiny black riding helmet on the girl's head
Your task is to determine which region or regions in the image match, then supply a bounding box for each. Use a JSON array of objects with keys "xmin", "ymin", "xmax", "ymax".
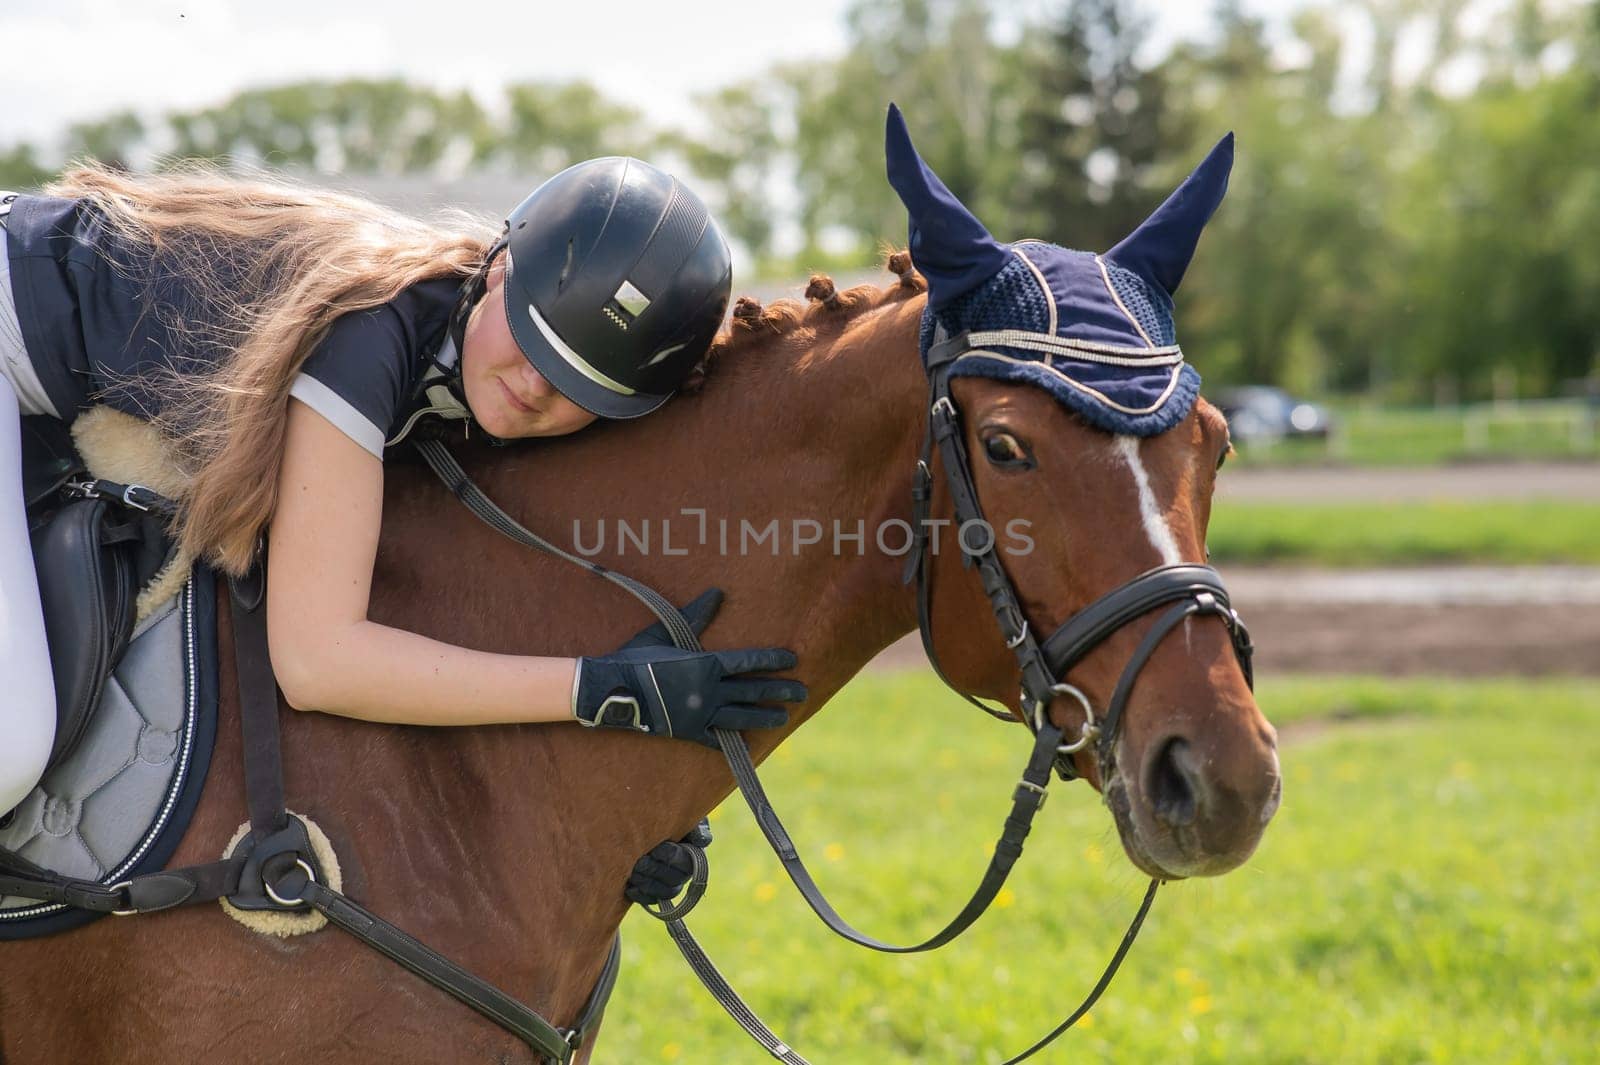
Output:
[{"xmin": 502, "ymin": 157, "xmax": 733, "ymax": 417}]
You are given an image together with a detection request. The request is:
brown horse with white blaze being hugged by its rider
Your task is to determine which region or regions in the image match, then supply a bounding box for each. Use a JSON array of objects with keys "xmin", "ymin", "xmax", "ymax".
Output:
[{"xmin": 0, "ymin": 259, "xmax": 1278, "ymax": 1065}]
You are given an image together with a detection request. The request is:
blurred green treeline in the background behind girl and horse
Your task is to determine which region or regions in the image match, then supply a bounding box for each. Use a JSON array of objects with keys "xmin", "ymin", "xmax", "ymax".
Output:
[{"xmin": 0, "ymin": 0, "xmax": 1600, "ymax": 398}]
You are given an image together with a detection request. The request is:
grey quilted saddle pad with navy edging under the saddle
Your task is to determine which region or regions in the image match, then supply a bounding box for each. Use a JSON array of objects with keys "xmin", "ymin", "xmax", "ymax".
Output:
[{"xmin": 0, "ymin": 566, "xmax": 218, "ymax": 940}]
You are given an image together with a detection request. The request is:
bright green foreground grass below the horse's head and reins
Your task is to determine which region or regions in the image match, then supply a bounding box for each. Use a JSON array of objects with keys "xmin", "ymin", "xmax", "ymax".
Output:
[{"xmin": 595, "ymin": 673, "xmax": 1600, "ymax": 1065}]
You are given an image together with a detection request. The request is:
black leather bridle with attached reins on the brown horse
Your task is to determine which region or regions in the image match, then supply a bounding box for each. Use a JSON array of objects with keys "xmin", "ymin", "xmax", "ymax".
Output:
[{"xmin": 406, "ymin": 316, "xmax": 1254, "ymax": 1065}]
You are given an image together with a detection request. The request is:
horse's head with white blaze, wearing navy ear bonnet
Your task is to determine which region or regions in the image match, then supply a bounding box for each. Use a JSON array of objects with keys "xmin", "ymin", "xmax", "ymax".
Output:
[{"xmin": 888, "ymin": 109, "xmax": 1280, "ymax": 878}]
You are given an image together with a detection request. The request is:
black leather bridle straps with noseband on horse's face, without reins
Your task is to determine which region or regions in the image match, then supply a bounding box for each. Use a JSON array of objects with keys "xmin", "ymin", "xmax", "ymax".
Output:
[{"xmin": 902, "ymin": 326, "xmax": 1254, "ymax": 784}]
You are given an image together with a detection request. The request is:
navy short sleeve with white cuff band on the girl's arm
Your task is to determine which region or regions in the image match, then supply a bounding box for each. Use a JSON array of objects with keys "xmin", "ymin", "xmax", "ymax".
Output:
[{"xmin": 290, "ymin": 305, "xmax": 413, "ymax": 459}]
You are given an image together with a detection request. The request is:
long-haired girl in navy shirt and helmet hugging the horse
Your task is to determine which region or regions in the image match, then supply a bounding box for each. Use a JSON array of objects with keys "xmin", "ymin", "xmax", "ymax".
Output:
[{"xmin": 0, "ymin": 158, "xmax": 805, "ymax": 811}]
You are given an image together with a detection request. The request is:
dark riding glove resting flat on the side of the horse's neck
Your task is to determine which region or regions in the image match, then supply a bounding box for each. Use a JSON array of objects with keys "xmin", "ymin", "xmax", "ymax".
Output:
[{"xmin": 573, "ymin": 588, "xmax": 806, "ymax": 748}]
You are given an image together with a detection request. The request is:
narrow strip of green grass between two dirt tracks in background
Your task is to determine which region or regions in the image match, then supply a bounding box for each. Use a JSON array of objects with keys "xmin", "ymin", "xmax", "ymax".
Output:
[{"xmin": 1206, "ymin": 502, "xmax": 1600, "ymax": 566}]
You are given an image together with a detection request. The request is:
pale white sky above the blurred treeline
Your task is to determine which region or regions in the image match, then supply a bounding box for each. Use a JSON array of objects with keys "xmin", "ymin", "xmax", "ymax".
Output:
[{"xmin": 0, "ymin": 0, "xmax": 1235, "ymax": 147}]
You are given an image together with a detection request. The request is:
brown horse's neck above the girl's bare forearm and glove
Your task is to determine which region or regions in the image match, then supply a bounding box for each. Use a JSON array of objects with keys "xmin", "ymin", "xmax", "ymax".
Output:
[{"xmin": 374, "ymin": 295, "xmax": 926, "ymax": 697}]
